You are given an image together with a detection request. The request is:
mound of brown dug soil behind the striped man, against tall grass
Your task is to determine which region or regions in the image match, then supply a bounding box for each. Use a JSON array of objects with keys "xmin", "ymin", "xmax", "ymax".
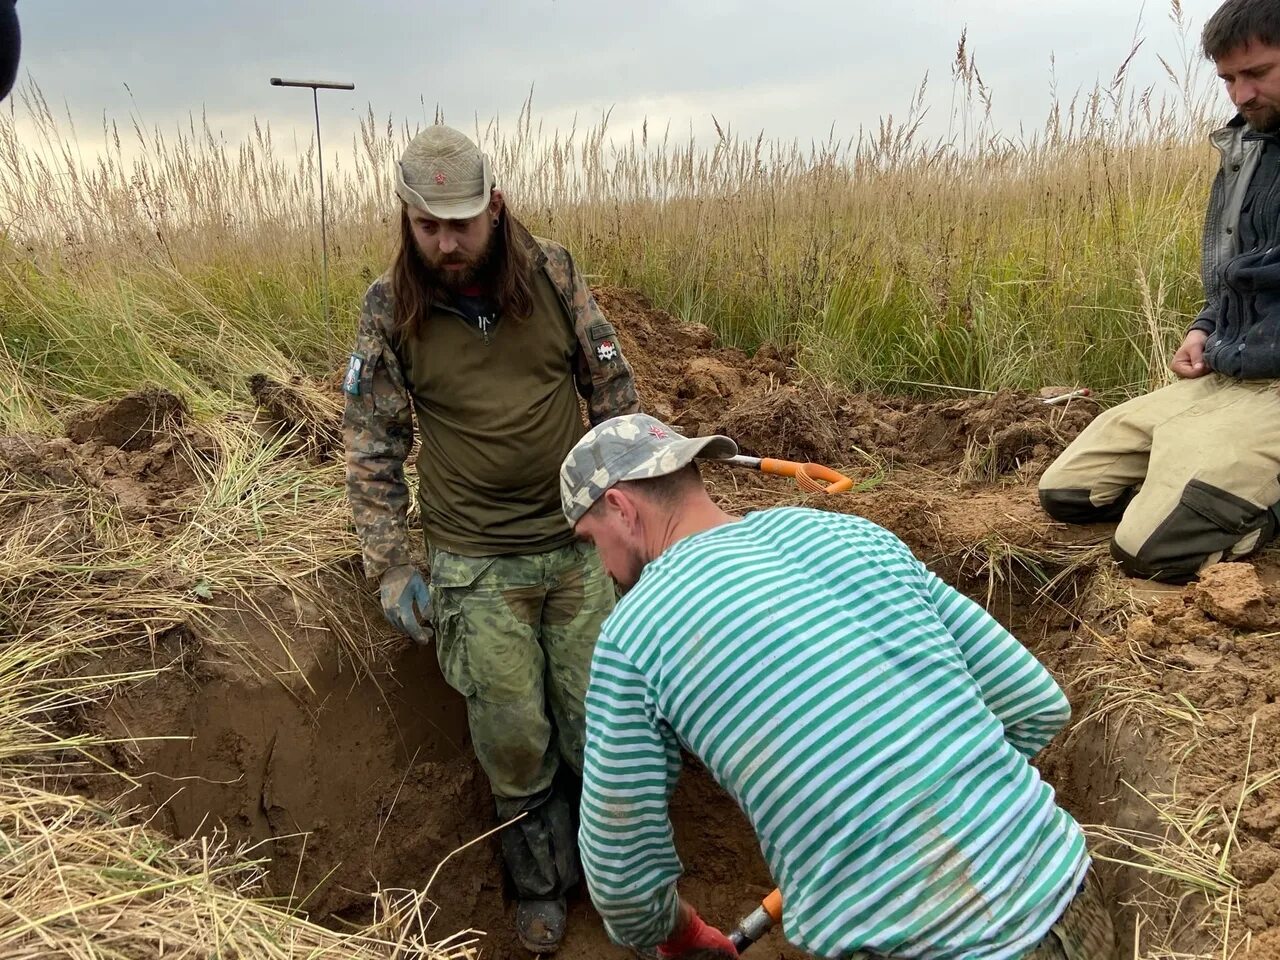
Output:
[{"xmin": 596, "ymin": 289, "xmax": 1097, "ymax": 479}]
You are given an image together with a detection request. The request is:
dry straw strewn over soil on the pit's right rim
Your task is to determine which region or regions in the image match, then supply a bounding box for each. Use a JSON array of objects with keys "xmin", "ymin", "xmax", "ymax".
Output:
[{"xmin": 1064, "ymin": 611, "xmax": 1280, "ymax": 960}]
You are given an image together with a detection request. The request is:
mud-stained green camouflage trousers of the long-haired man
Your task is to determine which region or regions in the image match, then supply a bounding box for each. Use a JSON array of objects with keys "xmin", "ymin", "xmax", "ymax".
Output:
[{"xmin": 430, "ymin": 544, "xmax": 614, "ymax": 899}]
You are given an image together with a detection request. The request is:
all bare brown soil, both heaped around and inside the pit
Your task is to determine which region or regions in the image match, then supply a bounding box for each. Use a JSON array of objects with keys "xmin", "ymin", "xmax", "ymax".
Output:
[{"xmin": 0, "ymin": 289, "xmax": 1280, "ymax": 960}]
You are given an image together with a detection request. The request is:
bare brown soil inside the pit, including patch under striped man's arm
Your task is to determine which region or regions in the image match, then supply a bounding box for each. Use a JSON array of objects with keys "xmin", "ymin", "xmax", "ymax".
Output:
[{"xmin": 93, "ymin": 588, "xmax": 803, "ymax": 960}]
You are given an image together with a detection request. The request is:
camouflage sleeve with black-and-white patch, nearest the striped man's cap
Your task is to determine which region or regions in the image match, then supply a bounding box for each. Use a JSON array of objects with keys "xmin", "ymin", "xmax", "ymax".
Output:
[{"xmin": 544, "ymin": 243, "xmax": 640, "ymax": 426}]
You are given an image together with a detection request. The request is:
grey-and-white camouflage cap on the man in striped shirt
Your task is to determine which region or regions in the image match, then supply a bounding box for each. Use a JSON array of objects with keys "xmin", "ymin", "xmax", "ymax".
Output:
[{"xmin": 561, "ymin": 413, "xmax": 737, "ymax": 526}]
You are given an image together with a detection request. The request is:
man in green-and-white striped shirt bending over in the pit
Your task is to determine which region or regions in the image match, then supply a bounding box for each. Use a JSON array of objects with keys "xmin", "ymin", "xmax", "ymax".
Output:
[{"xmin": 561, "ymin": 415, "xmax": 1114, "ymax": 960}]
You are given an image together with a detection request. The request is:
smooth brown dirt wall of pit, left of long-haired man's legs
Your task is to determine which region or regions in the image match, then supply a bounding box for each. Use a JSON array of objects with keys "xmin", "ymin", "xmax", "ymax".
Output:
[{"xmin": 90, "ymin": 584, "xmax": 489, "ymax": 925}]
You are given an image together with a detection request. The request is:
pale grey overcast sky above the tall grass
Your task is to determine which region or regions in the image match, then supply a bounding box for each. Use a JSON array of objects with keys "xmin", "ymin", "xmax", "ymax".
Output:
[{"xmin": 18, "ymin": 0, "xmax": 1226, "ymax": 163}]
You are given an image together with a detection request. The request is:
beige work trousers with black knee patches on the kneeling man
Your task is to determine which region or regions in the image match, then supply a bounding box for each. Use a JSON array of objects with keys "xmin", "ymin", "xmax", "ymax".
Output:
[{"xmin": 1039, "ymin": 374, "xmax": 1280, "ymax": 582}]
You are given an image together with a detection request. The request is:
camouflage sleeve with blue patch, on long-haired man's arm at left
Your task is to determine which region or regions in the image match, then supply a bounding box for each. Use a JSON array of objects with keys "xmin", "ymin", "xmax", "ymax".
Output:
[{"xmin": 342, "ymin": 280, "xmax": 413, "ymax": 580}]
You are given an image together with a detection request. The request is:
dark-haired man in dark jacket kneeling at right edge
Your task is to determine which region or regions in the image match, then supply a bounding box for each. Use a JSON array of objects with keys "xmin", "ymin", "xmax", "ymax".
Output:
[{"xmin": 1039, "ymin": 0, "xmax": 1280, "ymax": 582}]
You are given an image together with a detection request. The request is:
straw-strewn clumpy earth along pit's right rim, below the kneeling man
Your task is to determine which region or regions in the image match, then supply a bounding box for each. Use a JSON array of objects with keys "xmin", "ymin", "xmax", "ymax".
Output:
[{"xmin": 1055, "ymin": 557, "xmax": 1280, "ymax": 957}]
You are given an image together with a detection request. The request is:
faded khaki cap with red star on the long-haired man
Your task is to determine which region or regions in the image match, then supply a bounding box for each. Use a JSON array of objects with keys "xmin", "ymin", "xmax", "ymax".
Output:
[{"xmin": 396, "ymin": 123, "xmax": 494, "ymax": 220}]
